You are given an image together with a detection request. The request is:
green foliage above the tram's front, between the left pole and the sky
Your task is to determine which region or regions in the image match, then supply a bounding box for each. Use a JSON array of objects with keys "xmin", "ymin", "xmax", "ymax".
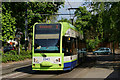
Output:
[{"xmin": 27, "ymin": 2, "xmax": 63, "ymax": 34}]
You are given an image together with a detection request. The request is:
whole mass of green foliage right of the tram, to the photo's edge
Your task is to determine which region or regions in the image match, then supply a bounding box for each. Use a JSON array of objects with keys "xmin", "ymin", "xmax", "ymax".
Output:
[{"xmin": 75, "ymin": 2, "xmax": 120, "ymax": 49}]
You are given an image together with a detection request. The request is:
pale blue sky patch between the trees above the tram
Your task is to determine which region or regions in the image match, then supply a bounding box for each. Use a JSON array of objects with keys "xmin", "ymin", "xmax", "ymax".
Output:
[{"xmin": 57, "ymin": 0, "xmax": 83, "ymax": 20}]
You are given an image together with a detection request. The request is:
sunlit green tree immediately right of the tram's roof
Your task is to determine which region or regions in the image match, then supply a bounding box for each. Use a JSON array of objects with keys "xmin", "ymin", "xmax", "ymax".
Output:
[{"xmin": 75, "ymin": 6, "xmax": 100, "ymax": 49}]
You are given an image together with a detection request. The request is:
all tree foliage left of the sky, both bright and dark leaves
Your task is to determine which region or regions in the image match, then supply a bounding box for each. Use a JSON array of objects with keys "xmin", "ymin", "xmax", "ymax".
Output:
[{"xmin": 2, "ymin": 2, "xmax": 63, "ymax": 44}]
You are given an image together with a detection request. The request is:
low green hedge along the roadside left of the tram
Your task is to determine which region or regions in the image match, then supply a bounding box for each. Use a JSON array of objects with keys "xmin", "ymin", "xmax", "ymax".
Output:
[{"xmin": 2, "ymin": 50, "xmax": 32, "ymax": 63}]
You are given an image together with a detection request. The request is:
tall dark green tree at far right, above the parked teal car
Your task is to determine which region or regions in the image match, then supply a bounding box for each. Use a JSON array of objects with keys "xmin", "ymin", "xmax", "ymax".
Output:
[{"xmin": 79, "ymin": 2, "xmax": 120, "ymax": 51}]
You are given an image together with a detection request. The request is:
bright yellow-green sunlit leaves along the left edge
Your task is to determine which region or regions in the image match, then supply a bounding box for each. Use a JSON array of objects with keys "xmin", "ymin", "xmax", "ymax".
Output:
[{"xmin": 2, "ymin": 5, "xmax": 16, "ymax": 41}]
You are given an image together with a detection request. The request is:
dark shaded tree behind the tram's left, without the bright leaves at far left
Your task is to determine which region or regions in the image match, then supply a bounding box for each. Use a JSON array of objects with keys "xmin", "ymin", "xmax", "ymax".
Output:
[{"xmin": 2, "ymin": 2, "xmax": 63, "ymax": 50}]
